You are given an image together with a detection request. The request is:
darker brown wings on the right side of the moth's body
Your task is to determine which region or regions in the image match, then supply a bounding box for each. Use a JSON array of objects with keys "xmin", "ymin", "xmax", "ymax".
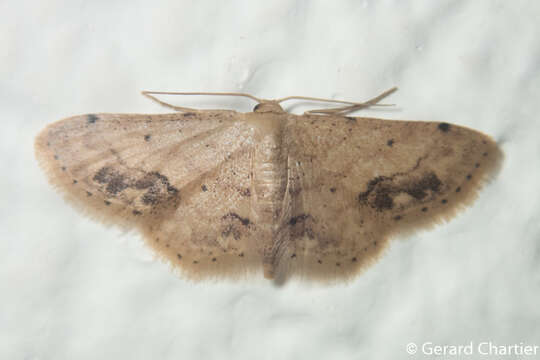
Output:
[{"xmin": 286, "ymin": 116, "xmax": 502, "ymax": 279}]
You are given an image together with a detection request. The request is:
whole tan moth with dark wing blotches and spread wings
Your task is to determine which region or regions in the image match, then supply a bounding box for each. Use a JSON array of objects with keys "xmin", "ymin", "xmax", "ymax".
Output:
[{"xmin": 35, "ymin": 88, "xmax": 502, "ymax": 282}]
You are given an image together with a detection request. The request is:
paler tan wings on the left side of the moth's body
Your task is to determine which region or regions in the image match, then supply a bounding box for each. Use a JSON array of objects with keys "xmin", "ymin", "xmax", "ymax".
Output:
[{"xmin": 35, "ymin": 111, "xmax": 257, "ymax": 276}]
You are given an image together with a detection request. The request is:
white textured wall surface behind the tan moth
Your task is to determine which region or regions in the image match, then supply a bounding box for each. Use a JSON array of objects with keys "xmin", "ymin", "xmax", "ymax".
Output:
[{"xmin": 0, "ymin": 0, "xmax": 540, "ymax": 359}]
